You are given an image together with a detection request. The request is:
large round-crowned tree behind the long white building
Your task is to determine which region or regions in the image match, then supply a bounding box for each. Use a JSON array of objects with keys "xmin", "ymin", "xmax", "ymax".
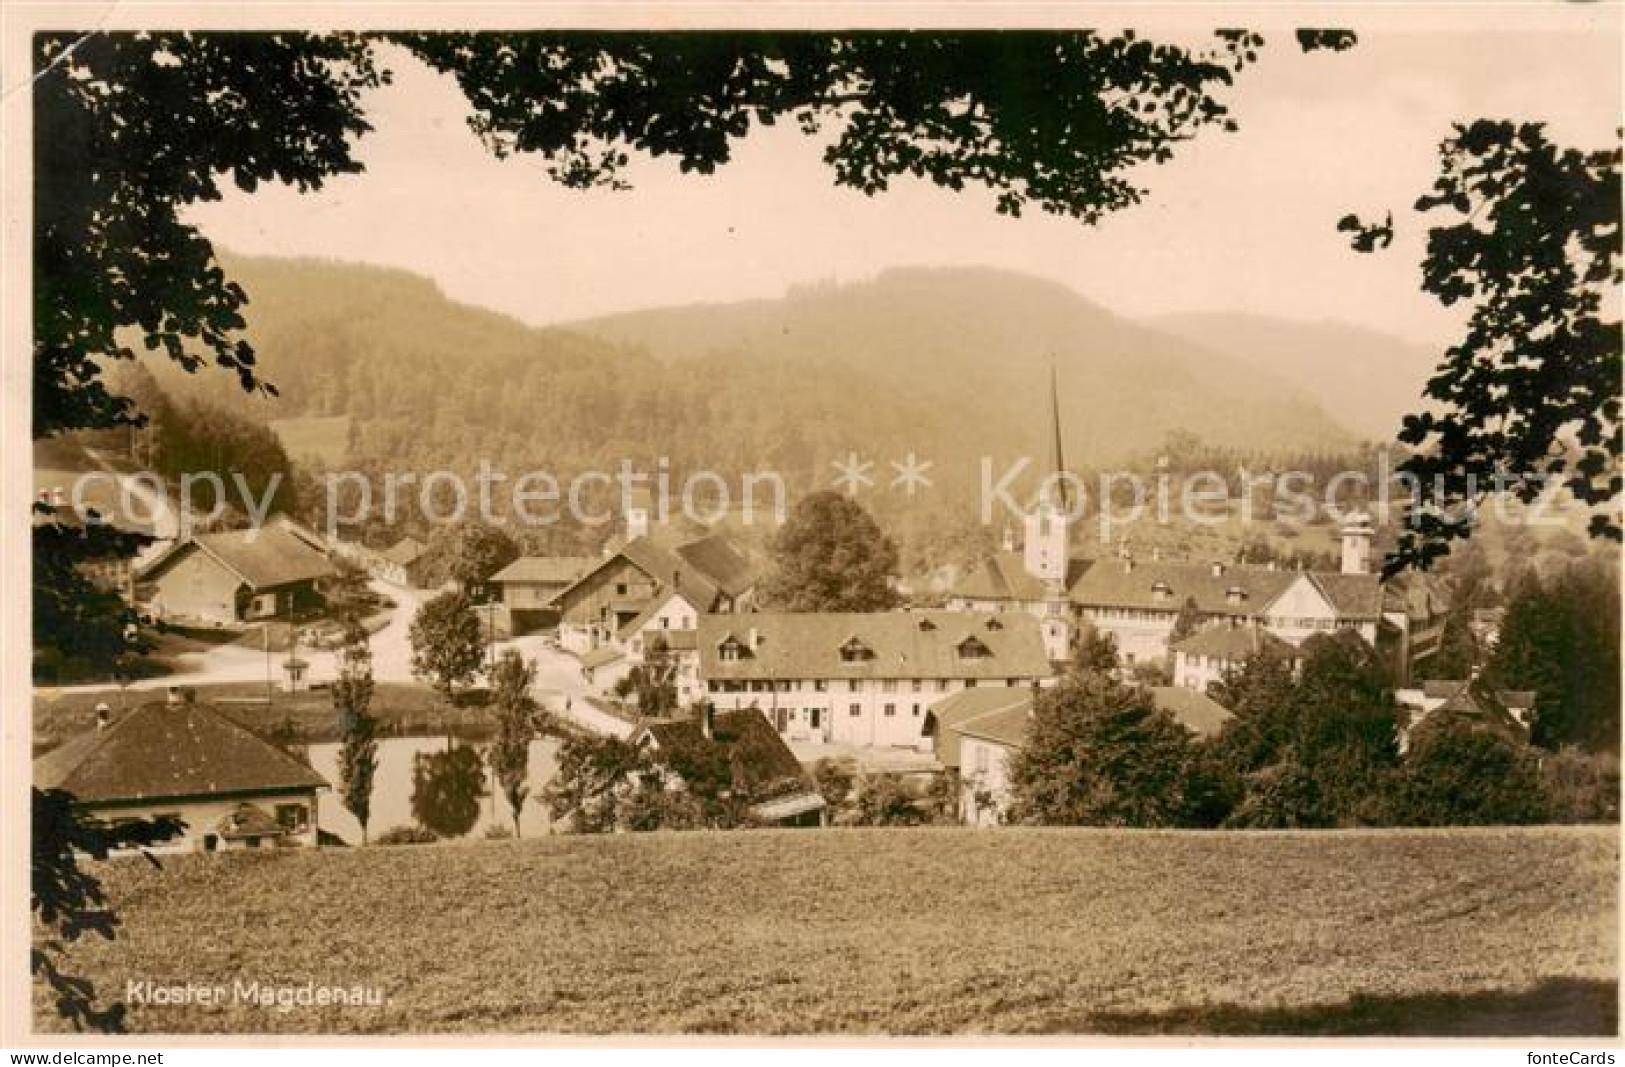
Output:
[{"xmin": 762, "ymin": 489, "xmax": 899, "ymax": 612}]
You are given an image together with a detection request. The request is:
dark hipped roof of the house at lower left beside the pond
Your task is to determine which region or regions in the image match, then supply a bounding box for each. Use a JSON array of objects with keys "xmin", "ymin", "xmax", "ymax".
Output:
[{"xmin": 34, "ymin": 702, "xmax": 327, "ymax": 802}]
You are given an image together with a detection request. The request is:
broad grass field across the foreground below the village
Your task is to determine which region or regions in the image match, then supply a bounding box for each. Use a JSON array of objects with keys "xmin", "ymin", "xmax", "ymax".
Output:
[{"xmin": 36, "ymin": 828, "xmax": 1619, "ymax": 1035}]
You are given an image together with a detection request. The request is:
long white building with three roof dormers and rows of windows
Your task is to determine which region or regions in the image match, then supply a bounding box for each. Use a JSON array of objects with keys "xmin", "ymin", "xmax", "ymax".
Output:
[{"xmin": 697, "ymin": 611, "xmax": 1053, "ymax": 752}]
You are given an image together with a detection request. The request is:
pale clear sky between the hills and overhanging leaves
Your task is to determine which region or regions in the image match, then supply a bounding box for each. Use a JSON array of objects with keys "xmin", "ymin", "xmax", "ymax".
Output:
[{"xmin": 189, "ymin": 13, "xmax": 1620, "ymax": 344}]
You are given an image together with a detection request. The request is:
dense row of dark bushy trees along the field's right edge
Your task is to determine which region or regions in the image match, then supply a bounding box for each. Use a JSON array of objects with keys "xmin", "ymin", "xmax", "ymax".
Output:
[{"xmin": 1009, "ymin": 633, "xmax": 1619, "ymax": 828}]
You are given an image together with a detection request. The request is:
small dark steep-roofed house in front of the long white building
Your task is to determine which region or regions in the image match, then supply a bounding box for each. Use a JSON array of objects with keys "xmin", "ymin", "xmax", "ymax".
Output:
[{"xmin": 632, "ymin": 705, "xmax": 827, "ymax": 827}]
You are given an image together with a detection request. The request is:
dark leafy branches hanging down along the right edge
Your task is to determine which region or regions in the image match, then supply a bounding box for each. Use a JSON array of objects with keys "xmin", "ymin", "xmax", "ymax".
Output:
[{"xmin": 1339, "ymin": 119, "xmax": 1622, "ymax": 573}]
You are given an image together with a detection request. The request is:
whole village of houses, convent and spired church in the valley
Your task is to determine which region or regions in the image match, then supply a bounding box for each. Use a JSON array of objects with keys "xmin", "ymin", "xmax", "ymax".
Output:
[{"xmin": 36, "ymin": 375, "xmax": 1536, "ymax": 851}]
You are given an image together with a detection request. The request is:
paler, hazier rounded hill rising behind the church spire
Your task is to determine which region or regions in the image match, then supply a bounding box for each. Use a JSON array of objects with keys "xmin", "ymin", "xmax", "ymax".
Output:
[{"xmin": 570, "ymin": 268, "xmax": 1350, "ymax": 464}]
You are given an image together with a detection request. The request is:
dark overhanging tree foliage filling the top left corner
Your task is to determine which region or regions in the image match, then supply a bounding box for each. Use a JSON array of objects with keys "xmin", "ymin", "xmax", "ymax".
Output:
[{"xmin": 33, "ymin": 32, "xmax": 388, "ymax": 437}]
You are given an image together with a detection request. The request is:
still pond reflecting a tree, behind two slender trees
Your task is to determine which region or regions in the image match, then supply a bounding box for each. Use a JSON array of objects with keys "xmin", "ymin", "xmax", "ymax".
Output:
[{"xmin": 309, "ymin": 737, "xmax": 559, "ymax": 845}]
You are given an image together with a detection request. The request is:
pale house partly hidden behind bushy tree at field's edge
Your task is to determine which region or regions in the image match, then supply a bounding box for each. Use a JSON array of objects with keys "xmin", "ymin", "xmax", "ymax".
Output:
[{"xmin": 933, "ymin": 685, "xmax": 1235, "ymax": 827}]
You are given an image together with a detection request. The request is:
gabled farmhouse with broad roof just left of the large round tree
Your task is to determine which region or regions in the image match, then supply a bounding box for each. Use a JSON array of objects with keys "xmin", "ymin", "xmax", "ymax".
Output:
[{"xmin": 553, "ymin": 534, "xmax": 756, "ymax": 654}]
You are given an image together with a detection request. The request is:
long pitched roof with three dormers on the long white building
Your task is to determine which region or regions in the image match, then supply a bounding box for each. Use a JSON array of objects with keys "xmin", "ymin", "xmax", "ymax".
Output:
[{"xmin": 699, "ymin": 611, "xmax": 1051, "ymax": 679}]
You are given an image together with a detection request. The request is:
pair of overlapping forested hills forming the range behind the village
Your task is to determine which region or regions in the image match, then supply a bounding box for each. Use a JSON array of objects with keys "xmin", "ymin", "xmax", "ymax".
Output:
[{"xmin": 133, "ymin": 257, "xmax": 1349, "ymax": 561}]
